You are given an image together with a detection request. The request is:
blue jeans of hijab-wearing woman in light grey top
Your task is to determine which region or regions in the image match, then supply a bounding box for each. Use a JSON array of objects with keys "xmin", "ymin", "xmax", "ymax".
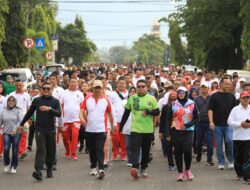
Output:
[{"xmin": 4, "ymin": 134, "xmax": 21, "ymax": 169}]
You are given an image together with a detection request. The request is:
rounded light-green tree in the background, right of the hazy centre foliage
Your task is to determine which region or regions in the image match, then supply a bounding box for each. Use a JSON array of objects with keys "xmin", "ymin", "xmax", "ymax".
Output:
[{"xmin": 133, "ymin": 34, "xmax": 167, "ymax": 64}]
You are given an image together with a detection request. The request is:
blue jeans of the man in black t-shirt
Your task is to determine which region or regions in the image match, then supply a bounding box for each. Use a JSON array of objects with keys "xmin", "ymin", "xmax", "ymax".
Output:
[{"xmin": 214, "ymin": 125, "xmax": 234, "ymax": 165}]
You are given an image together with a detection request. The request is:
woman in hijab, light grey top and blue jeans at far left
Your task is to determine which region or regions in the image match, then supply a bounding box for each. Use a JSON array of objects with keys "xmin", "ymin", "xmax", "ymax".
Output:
[{"xmin": 0, "ymin": 96, "xmax": 23, "ymax": 174}]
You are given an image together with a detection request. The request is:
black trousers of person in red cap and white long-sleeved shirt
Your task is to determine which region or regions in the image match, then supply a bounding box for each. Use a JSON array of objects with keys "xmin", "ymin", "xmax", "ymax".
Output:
[{"xmin": 234, "ymin": 140, "xmax": 250, "ymax": 180}]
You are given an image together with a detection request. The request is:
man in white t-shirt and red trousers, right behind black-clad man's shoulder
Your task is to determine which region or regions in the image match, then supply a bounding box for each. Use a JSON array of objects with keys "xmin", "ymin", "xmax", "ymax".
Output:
[{"xmin": 62, "ymin": 78, "xmax": 84, "ymax": 160}]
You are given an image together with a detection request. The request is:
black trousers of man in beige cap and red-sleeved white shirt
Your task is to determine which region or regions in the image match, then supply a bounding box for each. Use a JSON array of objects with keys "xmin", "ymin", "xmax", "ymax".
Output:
[{"xmin": 86, "ymin": 132, "xmax": 107, "ymax": 170}]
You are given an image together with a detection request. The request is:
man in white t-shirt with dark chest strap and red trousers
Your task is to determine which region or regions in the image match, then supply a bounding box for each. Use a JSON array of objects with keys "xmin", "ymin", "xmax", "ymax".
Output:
[{"xmin": 108, "ymin": 77, "xmax": 128, "ymax": 161}]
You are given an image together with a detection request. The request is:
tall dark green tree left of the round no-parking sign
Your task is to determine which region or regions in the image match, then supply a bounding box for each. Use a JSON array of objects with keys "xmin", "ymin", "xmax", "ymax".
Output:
[{"xmin": 1, "ymin": 0, "xmax": 27, "ymax": 66}]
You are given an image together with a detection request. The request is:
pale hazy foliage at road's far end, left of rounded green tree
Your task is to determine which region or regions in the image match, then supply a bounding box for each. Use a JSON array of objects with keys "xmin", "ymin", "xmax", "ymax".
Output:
[{"xmin": 109, "ymin": 46, "xmax": 137, "ymax": 64}]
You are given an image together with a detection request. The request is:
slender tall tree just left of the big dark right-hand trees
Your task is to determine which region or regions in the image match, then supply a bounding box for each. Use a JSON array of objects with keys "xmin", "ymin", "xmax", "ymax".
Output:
[{"xmin": 159, "ymin": 14, "xmax": 187, "ymax": 65}]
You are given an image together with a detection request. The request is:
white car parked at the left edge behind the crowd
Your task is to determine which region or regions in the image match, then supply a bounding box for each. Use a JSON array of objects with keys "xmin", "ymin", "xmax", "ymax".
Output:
[{"xmin": 0, "ymin": 68, "xmax": 36, "ymax": 90}]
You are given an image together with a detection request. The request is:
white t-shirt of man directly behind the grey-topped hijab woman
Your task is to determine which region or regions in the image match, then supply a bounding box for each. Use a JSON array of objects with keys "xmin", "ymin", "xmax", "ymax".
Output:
[{"xmin": 7, "ymin": 92, "xmax": 31, "ymax": 115}]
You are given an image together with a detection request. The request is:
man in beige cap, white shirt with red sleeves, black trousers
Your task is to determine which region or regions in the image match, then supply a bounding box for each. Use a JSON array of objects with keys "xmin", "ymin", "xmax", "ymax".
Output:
[{"xmin": 80, "ymin": 80, "xmax": 113, "ymax": 179}]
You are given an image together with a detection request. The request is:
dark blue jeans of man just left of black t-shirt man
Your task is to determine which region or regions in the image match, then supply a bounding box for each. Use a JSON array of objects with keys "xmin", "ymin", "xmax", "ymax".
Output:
[{"xmin": 196, "ymin": 123, "xmax": 213, "ymax": 162}]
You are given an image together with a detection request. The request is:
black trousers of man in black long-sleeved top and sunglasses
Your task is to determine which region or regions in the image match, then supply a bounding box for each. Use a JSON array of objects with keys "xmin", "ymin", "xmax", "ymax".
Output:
[{"xmin": 35, "ymin": 131, "xmax": 56, "ymax": 170}]
